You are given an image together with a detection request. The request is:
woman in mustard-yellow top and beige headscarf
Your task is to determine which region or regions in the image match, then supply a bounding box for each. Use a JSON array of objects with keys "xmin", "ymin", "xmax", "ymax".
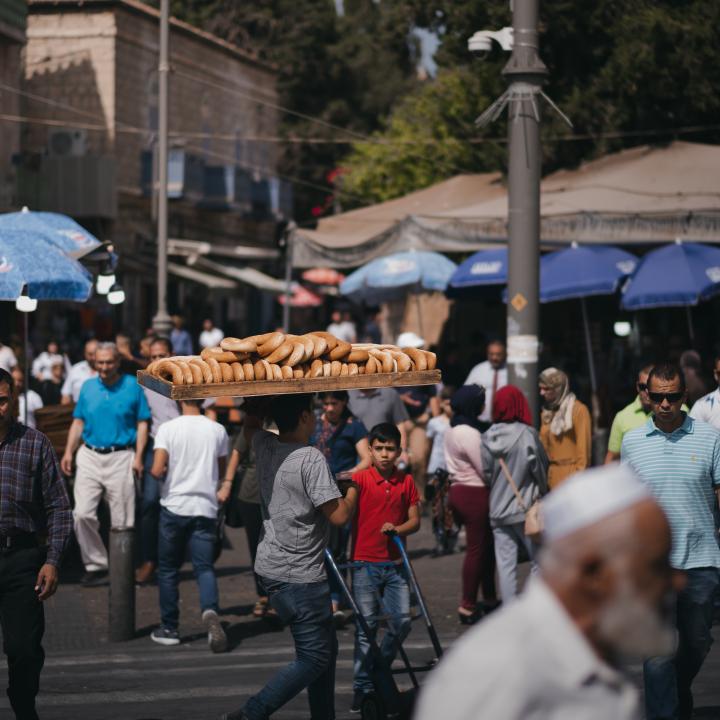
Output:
[{"xmin": 539, "ymin": 368, "xmax": 592, "ymax": 490}]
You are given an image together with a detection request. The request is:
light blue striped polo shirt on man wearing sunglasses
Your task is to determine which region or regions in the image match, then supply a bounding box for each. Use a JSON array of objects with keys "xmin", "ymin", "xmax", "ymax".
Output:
[{"xmin": 620, "ymin": 415, "xmax": 720, "ymax": 570}]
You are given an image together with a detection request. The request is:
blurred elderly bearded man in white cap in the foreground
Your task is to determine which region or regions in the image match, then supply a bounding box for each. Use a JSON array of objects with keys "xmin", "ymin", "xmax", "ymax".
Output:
[{"xmin": 416, "ymin": 465, "xmax": 683, "ymax": 720}]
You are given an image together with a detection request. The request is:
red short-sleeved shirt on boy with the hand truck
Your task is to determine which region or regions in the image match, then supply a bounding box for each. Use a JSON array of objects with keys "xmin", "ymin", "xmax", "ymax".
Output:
[{"xmin": 352, "ymin": 467, "xmax": 420, "ymax": 562}]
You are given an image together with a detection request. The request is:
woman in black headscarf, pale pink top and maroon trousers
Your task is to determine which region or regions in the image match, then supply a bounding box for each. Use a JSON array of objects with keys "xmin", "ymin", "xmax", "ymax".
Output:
[{"xmin": 444, "ymin": 385, "xmax": 497, "ymax": 625}]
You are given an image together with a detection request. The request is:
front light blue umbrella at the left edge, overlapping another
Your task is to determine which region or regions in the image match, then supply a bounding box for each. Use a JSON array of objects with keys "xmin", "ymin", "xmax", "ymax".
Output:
[{"xmin": 0, "ymin": 228, "xmax": 92, "ymax": 302}]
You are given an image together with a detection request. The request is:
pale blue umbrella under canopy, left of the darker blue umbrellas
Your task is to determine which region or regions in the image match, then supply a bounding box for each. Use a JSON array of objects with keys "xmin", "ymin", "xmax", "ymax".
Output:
[{"xmin": 340, "ymin": 250, "xmax": 457, "ymax": 303}]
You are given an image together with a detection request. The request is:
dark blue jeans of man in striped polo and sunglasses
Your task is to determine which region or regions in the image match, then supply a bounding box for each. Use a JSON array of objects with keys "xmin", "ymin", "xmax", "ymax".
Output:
[{"xmin": 644, "ymin": 568, "xmax": 720, "ymax": 720}]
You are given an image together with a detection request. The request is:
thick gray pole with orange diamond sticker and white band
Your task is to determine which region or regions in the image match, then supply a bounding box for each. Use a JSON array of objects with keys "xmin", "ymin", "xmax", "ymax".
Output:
[{"xmin": 503, "ymin": 0, "xmax": 547, "ymax": 423}]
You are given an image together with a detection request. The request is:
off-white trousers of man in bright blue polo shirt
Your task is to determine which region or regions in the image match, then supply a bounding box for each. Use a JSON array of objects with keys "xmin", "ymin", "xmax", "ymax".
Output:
[{"xmin": 73, "ymin": 445, "xmax": 135, "ymax": 572}]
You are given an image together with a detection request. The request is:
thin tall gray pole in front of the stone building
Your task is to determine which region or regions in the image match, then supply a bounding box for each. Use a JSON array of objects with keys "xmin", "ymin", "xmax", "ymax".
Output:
[{"xmin": 153, "ymin": 0, "xmax": 172, "ymax": 335}]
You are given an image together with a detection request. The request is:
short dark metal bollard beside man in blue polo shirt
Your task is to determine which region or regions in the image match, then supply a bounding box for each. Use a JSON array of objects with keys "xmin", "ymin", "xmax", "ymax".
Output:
[{"xmin": 108, "ymin": 527, "xmax": 135, "ymax": 642}]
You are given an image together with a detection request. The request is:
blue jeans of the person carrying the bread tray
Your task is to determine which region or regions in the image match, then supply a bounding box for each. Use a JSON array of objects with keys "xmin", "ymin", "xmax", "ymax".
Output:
[{"xmin": 243, "ymin": 577, "xmax": 337, "ymax": 720}]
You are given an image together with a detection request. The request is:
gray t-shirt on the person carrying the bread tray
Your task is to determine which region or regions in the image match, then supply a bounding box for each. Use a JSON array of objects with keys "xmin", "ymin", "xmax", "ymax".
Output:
[{"xmin": 253, "ymin": 430, "xmax": 341, "ymax": 583}]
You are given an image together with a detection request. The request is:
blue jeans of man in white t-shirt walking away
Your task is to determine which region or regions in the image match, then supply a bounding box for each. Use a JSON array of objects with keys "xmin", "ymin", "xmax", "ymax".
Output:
[{"xmin": 158, "ymin": 508, "xmax": 218, "ymax": 630}]
